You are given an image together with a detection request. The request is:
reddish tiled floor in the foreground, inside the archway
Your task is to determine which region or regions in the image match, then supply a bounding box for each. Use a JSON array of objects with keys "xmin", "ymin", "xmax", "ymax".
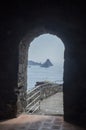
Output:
[{"xmin": 0, "ymin": 115, "xmax": 85, "ymax": 130}]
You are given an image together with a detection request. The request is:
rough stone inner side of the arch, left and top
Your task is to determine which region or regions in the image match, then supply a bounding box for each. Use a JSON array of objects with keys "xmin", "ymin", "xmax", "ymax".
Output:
[{"xmin": 18, "ymin": 27, "xmax": 65, "ymax": 114}]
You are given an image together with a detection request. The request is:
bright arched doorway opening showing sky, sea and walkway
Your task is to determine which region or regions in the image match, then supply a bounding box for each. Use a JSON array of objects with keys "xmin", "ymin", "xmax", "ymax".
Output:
[{"xmin": 27, "ymin": 33, "xmax": 65, "ymax": 115}]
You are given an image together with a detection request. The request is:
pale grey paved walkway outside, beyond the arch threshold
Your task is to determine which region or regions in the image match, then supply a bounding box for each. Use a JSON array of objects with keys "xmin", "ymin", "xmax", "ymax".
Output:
[{"xmin": 37, "ymin": 92, "xmax": 64, "ymax": 115}]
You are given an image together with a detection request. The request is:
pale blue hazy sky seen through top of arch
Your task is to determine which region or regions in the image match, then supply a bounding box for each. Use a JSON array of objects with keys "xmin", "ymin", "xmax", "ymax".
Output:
[{"xmin": 28, "ymin": 34, "xmax": 64, "ymax": 63}]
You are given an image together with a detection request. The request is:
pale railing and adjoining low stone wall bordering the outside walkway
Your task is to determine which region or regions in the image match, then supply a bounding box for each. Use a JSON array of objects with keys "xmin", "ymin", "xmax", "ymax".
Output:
[{"xmin": 26, "ymin": 83, "xmax": 60, "ymax": 114}]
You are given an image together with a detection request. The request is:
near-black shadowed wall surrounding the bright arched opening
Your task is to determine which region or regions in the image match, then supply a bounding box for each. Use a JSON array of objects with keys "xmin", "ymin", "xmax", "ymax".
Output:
[{"xmin": 0, "ymin": 0, "xmax": 86, "ymax": 125}]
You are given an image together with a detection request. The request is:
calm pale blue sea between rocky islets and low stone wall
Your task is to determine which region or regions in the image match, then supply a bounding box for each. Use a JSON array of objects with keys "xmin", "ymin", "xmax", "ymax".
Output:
[{"xmin": 27, "ymin": 64, "xmax": 63, "ymax": 89}]
